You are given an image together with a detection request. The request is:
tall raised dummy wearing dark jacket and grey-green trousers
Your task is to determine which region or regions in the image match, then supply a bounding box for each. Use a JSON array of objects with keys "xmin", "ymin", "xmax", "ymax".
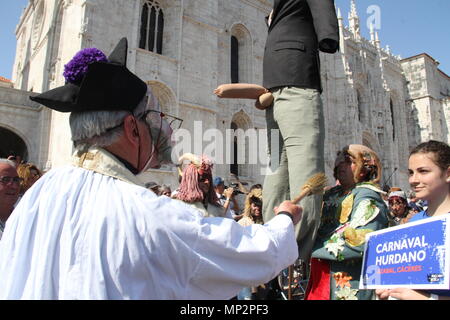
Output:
[{"xmin": 263, "ymin": 0, "xmax": 339, "ymax": 261}]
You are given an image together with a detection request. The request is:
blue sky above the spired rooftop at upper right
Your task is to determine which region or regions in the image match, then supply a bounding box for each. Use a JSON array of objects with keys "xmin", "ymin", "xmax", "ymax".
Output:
[{"xmin": 335, "ymin": 0, "xmax": 450, "ymax": 75}]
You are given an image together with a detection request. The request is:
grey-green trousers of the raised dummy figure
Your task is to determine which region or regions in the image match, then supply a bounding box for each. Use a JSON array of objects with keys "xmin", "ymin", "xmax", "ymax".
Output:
[{"xmin": 263, "ymin": 87, "xmax": 325, "ymax": 261}]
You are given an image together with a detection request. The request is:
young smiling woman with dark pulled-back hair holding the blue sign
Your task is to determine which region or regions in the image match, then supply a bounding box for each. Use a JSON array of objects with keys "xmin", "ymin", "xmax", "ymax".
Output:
[{"xmin": 377, "ymin": 140, "xmax": 450, "ymax": 300}]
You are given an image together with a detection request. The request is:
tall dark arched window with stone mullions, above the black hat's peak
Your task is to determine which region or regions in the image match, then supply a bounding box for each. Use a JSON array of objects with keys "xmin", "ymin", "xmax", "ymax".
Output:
[{"xmin": 139, "ymin": 0, "xmax": 164, "ymax": 54}]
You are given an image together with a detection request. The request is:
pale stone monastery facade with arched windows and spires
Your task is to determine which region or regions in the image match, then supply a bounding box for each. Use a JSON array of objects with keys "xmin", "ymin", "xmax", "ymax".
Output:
[{"xmin": 0, "ymin": 0, "xmax": 450, "ymax": 190}]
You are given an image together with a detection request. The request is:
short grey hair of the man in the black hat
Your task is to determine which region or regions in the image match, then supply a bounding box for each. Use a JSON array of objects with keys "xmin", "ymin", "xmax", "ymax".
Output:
[{"xmin": 69, "ymin": 94, "xmax": 148, "ymax": 153}]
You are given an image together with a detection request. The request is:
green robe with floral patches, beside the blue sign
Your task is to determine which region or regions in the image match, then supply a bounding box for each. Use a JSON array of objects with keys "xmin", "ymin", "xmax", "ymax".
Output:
[{"xmin": 312, "ymin": 183, "xmax": 388, "ymax": 300}]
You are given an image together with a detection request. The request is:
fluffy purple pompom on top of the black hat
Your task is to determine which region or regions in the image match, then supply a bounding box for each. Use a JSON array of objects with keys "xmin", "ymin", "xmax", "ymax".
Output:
[{"xmin": 63, "ymin": 48, "xmax": 108, "ymax": 84}]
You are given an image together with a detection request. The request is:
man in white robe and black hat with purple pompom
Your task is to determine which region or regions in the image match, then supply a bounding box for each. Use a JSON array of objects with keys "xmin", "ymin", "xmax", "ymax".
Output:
[{"xmin": 0, "ymin": 38, "xmax": 301, "ymax": 299}]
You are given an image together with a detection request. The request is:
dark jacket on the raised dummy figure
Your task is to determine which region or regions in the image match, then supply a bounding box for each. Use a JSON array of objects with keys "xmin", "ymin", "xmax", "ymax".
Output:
[{"xmin": 263, "ymin": 0, "xmax": 339, "ymax": 92}]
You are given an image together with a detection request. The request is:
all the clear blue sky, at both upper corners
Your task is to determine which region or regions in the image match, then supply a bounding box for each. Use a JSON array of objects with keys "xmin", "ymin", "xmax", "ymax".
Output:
[{"xmin": 0, "ymin": 0, "xmax": 450, "ymax": 79}]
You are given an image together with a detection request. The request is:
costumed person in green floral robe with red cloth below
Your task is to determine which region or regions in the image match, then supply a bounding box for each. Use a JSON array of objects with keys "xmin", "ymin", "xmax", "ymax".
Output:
[{"xmin": 306, "ymin": 145, "xmax": 388, "ymax": 300}]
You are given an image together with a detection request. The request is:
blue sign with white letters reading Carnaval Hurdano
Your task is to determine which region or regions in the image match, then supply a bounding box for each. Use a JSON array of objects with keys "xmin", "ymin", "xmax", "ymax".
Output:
[{"xmin": 360, "ymin": 215, "xmax": 450, "ymax": 290}]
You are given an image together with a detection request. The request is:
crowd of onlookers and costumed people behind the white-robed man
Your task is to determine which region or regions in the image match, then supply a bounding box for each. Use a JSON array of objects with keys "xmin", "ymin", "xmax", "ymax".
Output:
[{"xmin": 0, "ymin": 141, "xmax": 450, "ymax": 300}]
